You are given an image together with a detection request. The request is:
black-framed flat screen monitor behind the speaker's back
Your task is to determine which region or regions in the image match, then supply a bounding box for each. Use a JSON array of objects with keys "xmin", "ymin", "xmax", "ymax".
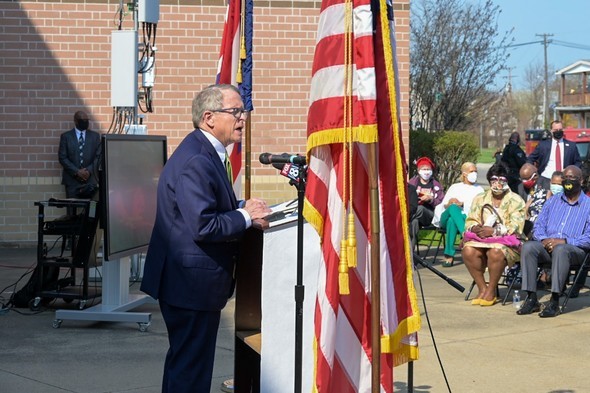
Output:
[{"xmin": 100, "ymin": 134, "xmax": 167, "ymax": 261}]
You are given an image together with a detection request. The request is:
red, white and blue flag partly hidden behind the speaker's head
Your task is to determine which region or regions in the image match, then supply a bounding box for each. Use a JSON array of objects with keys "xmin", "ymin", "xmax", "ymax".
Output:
[{"xmin": 215, "ymin": 0, "xmax": 254, "ymax": 196}]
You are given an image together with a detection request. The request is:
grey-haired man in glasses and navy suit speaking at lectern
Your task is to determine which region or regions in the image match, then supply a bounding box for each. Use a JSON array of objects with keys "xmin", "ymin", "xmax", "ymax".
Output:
[{"xmin": 141, "ymin": 85, "xmax": 270, "ymax": 393}]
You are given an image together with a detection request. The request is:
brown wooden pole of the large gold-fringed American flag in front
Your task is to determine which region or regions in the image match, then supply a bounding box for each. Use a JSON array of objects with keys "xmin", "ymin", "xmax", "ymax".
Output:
[{"xmin": 367, "ymin": 143, "xmax": 381, "ymax": 393}]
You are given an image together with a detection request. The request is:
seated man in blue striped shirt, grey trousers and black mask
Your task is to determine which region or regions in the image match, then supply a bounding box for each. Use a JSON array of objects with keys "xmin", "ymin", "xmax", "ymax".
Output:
[{"xmin": 516, "ymin": 165, "xmax": 590, "ymax": 318}]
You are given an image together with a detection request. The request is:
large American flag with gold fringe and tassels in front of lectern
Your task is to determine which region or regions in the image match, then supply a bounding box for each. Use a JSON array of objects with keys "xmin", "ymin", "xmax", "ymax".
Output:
[{"xmin": 304, "ymin": 0, "xmax": 420, "ymax": 393}]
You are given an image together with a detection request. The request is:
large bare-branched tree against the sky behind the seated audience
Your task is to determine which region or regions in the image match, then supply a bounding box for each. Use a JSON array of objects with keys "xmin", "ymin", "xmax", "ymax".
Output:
[{"xmin": 410, "ymin": 0, "xmax": 511, "ymax": 131}]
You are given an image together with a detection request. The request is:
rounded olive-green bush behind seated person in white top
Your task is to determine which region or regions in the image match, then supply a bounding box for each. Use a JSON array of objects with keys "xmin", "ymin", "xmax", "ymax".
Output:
[{"xmin": 434, "ymin": 131, "xmax": 479, "ymax": 190}]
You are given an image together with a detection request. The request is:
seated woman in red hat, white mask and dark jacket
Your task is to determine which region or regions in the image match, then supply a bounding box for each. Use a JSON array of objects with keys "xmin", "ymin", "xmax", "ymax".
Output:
[{"xmin": 408, "ymin": 157, "xmax": 445, "ymax": 249}]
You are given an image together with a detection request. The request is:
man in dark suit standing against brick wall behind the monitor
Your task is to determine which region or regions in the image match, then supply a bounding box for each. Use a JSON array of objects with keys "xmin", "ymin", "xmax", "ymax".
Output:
[{"xmin": 58, "ymin": 111, "xmax": 101, "ymax": 199}]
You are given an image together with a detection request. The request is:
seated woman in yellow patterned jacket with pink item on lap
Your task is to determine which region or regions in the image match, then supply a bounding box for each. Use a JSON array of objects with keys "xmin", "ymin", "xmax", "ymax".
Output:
[{"xmin": 462, "ymin": 163, "xmax": 525, "ymax": 306}]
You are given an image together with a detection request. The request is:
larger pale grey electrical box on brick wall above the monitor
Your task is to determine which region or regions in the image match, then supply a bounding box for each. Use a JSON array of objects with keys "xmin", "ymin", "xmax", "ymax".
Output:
[{"xmin": 111, "ymin": 30, "xmax": 137, "ymax": 107}]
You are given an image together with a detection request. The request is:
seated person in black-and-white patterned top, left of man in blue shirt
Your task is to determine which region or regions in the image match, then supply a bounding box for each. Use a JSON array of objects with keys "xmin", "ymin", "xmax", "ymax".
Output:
[{"xmin": 518, "ymin": 163, "xmax": 550, "ymax": 238}]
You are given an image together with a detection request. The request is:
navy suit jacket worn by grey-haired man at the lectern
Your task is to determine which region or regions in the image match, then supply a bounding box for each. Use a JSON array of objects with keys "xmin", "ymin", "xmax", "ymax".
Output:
[{"xmin": 141, "ymin": 129, "xmax": 246, "ymax": 311}]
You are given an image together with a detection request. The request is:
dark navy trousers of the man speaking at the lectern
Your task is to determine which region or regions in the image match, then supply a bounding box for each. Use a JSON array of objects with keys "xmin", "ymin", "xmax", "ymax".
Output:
[{"xmin": 160, "ymin": 300, "xmax": 221, "ymax": 393}]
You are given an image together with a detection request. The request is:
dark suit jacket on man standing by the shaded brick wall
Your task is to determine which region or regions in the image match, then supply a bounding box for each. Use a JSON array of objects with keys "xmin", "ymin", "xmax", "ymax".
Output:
[{"xmin": 58, "ymin": 128, "xmax": 102, "ymax": 187}]
